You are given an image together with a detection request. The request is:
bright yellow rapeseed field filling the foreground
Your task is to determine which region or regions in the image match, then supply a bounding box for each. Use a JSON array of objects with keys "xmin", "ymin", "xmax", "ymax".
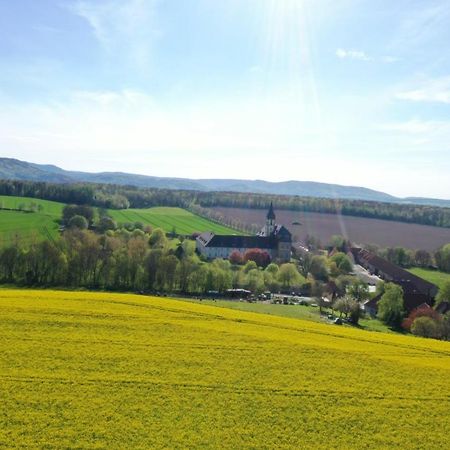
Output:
[{"xmin": 0, "ymin": 290, "xmax": 450, "ymax": 449}]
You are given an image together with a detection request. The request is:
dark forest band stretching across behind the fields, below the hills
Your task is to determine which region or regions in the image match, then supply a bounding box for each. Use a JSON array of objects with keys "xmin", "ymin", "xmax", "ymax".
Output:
[{"xmin": 0, "ymin": 180, "xmax": 450, "ymax": 228}]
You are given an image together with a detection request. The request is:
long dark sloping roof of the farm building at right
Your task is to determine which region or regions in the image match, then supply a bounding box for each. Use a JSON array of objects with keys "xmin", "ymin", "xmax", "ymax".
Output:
[{"xmin": 352, "ymin": 248, "xmax": 437, "ymax": 303}]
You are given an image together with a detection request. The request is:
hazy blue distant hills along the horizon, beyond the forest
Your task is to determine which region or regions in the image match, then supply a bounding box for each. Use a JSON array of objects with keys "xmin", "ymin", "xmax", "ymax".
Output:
[{"xmin": 0, "ymin": 158, "xmax": 450, "ymax": 207}]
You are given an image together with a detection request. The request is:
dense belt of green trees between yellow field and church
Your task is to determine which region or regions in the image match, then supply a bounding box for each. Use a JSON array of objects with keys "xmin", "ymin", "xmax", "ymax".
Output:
[{"xmin": 0, "ymin": 229, "xmax": 305, "ymax": 295}]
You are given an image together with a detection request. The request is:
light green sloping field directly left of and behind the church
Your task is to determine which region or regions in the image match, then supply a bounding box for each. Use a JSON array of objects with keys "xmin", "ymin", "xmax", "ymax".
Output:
[{"xmin": 108, "ymin": 207, "xmax": 241, "ymax": 235}]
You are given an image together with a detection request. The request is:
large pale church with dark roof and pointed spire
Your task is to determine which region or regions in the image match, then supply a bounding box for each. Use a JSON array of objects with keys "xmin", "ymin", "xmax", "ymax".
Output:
[{"xmin": 197, "ymin": 203, "xmax": 292, "ymax": 262}]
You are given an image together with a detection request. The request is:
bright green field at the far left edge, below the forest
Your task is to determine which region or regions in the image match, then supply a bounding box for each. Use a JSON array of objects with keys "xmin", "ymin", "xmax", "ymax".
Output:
[{"xmin": 0, "ymin": 196, "xmax": 64, "ymax": 247}]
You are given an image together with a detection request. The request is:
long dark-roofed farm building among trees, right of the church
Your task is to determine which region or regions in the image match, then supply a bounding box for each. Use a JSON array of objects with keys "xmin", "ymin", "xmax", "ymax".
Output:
[{"xmin": 351, "ymin": 248, "xmax": 438, "ymax": 313}]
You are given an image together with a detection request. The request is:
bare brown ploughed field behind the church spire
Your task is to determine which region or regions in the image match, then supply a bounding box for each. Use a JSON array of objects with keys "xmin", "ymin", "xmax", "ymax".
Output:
[{"xmin": 211, "ymin": 207, "xmax": 450, "ymax": 251}]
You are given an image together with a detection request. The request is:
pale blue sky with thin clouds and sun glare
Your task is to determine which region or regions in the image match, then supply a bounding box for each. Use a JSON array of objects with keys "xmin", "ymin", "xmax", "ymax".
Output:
[{"xmin": 0, "ymin": 0, "xmax": 450, "ymax": 198}]
